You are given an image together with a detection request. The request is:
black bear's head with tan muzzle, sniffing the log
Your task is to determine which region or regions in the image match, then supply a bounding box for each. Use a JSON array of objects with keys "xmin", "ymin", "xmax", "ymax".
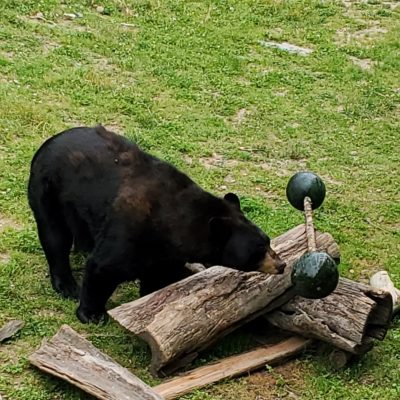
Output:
[{"xmin": 209, "ymin": 193, "xmax": 286, "ymax": 274}]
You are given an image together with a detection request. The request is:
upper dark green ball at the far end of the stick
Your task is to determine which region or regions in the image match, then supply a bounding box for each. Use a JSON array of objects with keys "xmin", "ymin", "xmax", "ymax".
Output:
[{"xmin": 286, "ymin": 171, "xmax": 326, "ymax": 210}]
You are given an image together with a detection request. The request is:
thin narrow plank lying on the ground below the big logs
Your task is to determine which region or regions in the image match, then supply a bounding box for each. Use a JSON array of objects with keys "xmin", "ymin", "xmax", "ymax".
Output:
[{"xmin": 153, "ymin": 336, "xmax": 311, "ymax": 400}]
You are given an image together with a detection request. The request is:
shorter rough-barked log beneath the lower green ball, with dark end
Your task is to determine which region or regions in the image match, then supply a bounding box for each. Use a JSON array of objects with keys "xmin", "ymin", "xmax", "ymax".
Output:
[{"xmin": 264, "ymin": 278, "xmax": 392, "ymax": 354}]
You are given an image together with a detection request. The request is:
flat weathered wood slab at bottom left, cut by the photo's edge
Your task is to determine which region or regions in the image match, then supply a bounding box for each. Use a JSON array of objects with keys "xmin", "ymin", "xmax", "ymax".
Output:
[{"xmin": 29, "ymin": 325, "xmax": 163, "ymax": 400}]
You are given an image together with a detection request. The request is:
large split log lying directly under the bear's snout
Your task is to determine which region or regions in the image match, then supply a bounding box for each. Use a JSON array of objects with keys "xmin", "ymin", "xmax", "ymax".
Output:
[{"xmin": 109, "ymin": 225, "xmax": 339, "ymax": 374}]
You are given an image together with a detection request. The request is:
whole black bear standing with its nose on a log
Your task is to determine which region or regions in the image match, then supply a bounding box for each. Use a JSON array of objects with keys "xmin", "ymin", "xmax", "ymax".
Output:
[{"xmin": 28, "ymin": 126, "xmax": 285, "ymax": 322}]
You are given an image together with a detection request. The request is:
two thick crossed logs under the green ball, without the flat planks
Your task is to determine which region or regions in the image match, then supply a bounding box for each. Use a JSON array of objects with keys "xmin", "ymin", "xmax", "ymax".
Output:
[{"xmin": 109, "ymin": 225, "xmax": 392, "ymax": 374}]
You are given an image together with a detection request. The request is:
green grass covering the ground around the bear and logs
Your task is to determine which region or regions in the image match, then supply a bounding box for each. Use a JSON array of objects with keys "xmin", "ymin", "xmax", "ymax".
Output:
[{"xmin": 0, "ymin": 0, "xmax": 400, "ymax": 400}]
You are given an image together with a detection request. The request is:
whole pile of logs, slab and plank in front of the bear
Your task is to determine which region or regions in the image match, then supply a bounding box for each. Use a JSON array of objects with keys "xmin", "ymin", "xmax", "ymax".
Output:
[{"xmin": 30, "ymin": 225, "xmax": 400, "ymax": 400}]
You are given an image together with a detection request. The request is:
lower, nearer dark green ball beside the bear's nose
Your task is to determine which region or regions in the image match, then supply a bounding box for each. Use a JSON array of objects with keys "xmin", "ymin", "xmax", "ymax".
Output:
[{"xmin": 291, "ymin": 252, "xmax": 339, "ymax": 299}]
